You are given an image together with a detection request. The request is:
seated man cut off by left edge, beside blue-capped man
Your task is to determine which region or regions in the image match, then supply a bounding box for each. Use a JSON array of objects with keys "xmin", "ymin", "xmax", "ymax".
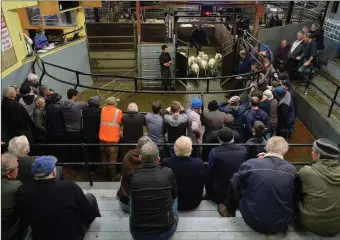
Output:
[{"xmin": 1, "ymin": 153, "xmax": 22, "ymax": 239}]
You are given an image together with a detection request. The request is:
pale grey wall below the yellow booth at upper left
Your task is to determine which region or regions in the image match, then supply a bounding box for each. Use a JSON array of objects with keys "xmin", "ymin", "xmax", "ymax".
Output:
[{"xmin": 1, "ymin": 41, "xmax": 92, "ymax": 96}]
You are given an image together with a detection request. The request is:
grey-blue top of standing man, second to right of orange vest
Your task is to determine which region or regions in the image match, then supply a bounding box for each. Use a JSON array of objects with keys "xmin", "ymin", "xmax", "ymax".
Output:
[{"xmin": 145, "ymin": 113, "xmax": 165, "ymax": 143}]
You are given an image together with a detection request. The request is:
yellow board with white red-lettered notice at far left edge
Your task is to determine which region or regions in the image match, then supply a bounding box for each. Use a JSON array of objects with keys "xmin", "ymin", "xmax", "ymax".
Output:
[{"xmin": 1, "ymin": 12, "xmax": 18, "ymax": 72}]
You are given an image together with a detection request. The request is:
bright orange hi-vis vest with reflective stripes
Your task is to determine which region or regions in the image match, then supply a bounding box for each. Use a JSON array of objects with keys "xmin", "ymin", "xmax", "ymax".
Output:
[{"xmin": 99, "ymin": 106, "xmax": 123, "ymax": 143}]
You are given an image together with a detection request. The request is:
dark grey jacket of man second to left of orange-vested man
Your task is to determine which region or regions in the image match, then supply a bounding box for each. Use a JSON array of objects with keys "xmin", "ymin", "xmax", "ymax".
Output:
[{"xmin": 61, "ymin": 100, "xmax": 87, "ymax": 132}]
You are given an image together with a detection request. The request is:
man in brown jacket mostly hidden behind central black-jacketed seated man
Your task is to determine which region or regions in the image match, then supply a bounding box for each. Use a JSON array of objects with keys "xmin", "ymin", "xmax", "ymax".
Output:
[{"xmin": 117, "ymin": 136, "xmax": 152, "ymax": 213}]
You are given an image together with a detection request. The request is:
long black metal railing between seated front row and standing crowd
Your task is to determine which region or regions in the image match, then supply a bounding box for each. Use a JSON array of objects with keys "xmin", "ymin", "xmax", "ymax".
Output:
[{"xmin": 26, "ymin": 143, "xmax": 324, "ymax": 186}]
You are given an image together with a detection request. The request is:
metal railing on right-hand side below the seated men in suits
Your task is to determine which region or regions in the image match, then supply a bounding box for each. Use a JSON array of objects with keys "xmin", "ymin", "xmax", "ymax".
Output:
[{"xmin": 305, "ymin": 68, "xmax": 340, "ymax": 118}]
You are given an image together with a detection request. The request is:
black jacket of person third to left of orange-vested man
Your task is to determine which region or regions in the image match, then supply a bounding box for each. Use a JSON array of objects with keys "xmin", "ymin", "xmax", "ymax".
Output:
[{"xmin": 46, "ymin": 103, "xmax": 65, "ymax": 136}]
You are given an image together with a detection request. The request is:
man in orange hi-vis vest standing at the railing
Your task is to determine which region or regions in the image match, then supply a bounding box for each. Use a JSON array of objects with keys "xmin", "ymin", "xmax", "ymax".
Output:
[{"xmin": 99, "ymin": 97, "xmax": 123, "ymax": 181}]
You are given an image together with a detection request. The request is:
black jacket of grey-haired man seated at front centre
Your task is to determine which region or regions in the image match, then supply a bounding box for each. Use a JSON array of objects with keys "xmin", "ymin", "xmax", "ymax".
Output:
[{"xmin": 127, "ymin": 162, "xmax": 178, "ymax": 234}]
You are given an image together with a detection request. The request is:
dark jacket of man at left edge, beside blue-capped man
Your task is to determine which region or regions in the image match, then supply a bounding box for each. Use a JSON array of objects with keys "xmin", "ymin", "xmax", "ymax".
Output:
[{"xmin": 1, "ymin": 177, "xmax": 22, "ymax": 239}]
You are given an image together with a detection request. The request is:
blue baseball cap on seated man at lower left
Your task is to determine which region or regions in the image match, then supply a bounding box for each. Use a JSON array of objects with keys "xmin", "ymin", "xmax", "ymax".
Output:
[{"xmin": 31, "ymin": 156, "xmax": 58, "ymax": 178}]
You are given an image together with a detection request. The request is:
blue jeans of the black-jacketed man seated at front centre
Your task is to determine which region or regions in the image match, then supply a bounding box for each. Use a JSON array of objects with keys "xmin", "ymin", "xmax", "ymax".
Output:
[{"xmin": 130, "ymin": 198, "xmax": 178, "ymax": 240}]
